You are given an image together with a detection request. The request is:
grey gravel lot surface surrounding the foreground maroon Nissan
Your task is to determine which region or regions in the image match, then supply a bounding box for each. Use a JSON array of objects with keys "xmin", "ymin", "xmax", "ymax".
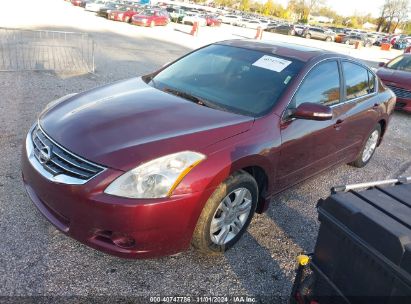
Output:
[{"xmin": 0, "ymin": 0, "xmax": 411, "ymax": 303}]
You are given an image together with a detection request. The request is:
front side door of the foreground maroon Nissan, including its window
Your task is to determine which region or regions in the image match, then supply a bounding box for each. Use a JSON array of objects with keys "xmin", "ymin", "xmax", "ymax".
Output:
[{"xmin": 276, "ymin": 60, "xmax": 344, "ymax": 190}]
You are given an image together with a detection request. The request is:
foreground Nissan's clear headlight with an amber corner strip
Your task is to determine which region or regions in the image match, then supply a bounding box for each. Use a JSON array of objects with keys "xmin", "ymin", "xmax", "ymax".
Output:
[{"xmin": 104, "ymin": 151, "xmax": 205, "ymax": 198}]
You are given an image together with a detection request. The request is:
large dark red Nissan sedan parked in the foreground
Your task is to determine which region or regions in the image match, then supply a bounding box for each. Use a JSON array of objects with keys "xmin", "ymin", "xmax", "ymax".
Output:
[{"xmin": 22, "ymin": 40, "xmax": 395, "ymax": 258}]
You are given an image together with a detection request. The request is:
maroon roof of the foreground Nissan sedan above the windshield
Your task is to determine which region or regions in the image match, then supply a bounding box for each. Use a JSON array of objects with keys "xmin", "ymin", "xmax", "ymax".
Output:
[{"xmin": 216, "ymin": 39, "xmax": 344, "ymax": 62}]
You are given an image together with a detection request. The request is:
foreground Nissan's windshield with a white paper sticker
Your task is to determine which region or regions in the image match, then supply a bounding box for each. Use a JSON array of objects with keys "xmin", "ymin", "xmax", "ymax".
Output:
[{"xmin": 149, "ymin": 44, "xmax": 303, "ymax": 117}]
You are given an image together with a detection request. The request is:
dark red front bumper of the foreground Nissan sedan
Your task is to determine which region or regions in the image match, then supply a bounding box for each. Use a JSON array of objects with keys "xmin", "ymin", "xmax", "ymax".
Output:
[{"xmin": 22, "ymin": 131, "xmax": 212, "ymax": 258}]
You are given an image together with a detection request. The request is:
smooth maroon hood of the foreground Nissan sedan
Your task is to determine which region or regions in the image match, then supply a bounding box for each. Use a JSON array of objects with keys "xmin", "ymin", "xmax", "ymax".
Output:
[{"xmin": 39, "ymin": 78, "xmax": 254, "ymax": 171}]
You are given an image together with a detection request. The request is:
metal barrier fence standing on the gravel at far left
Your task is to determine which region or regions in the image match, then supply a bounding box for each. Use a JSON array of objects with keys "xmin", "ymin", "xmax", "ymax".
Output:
[{"xmin": 0, "ymin": 27, "xmax": 95, "ymax": 73}]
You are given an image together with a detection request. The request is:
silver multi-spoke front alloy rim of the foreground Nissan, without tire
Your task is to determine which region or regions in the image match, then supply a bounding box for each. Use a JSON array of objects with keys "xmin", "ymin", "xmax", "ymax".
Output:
[{"xmin": 210, "ymin": 188, "xmax": 252, "ymax": 245}]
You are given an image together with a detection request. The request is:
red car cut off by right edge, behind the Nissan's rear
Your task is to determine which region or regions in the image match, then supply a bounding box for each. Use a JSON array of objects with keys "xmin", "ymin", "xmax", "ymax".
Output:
[{"xmin": 377, "ymin": 54, "xmax": 411, "ymax": 113}]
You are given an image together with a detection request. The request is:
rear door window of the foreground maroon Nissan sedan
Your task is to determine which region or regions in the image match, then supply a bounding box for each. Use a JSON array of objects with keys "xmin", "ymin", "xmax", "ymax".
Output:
[{"xmin": 342, "ymin": 62, "xmax": 369, "ymax": 100}]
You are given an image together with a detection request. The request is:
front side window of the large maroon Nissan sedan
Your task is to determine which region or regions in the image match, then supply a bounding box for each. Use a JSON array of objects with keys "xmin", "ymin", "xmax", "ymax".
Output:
[{"xmin": 291, "ymin": 61, "xmax": 340, "ymax": 107}]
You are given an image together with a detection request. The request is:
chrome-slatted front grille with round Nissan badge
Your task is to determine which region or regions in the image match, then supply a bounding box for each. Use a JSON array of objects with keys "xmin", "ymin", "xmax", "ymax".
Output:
[{"xmin": 31, "ymin": 126, "xmax": 104, "ymax": 180}]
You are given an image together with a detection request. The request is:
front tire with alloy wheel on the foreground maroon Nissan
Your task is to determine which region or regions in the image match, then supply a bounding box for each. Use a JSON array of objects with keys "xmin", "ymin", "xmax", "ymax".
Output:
[{"xmin": 191, "ymin": 171, "xmax": 258, "ymax": 254}]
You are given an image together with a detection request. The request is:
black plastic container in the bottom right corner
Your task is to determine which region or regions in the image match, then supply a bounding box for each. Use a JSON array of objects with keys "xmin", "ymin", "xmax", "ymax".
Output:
[{"xmin": 310, "ymin": 184, "xmax": 411, "ymax": 303}]
